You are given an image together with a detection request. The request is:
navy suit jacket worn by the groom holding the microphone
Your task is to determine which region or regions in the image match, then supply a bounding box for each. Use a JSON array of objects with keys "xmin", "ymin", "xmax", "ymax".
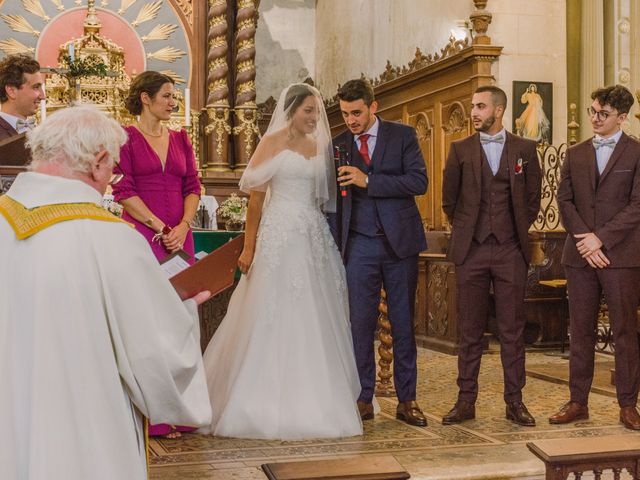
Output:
[{"xmin": 329, "ymin": 118, "xmax": 428, "ymax": 258}]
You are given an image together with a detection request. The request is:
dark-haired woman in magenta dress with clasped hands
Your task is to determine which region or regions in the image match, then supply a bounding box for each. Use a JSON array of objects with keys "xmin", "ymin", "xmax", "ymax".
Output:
[{"xmin": 113, "ymin": 71, "xmax": 200, "ymax": 438}]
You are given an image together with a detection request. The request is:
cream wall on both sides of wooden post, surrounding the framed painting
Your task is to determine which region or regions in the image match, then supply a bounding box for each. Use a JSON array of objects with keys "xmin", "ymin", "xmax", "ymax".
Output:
[{"xmin": 314, "ymin": 0, "xmax": 567, "ymax": 144}]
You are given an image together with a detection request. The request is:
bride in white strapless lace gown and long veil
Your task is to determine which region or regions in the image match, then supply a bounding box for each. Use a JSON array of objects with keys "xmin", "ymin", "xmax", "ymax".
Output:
[{"xmin": 204, "ymin": 84, "xmax": 362, "ymax": 440}]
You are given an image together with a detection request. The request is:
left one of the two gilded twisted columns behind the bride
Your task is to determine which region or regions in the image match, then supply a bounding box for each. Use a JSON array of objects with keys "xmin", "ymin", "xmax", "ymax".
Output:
[{"xmin": 201, "ymin": 0, "xmax": 231, "ymax": 172}]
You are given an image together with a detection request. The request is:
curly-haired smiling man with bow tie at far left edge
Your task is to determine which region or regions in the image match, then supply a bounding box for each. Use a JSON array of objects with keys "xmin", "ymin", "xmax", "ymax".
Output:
[{"xmin": 0, "ymin": 55, "xmax": 45, "ymax": 140}]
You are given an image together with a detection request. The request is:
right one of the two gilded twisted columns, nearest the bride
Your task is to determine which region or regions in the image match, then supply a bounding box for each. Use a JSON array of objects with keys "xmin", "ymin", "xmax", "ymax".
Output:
[{"xmin": 233, "ymin": 0, "xmax": 260, "ymax": 171}]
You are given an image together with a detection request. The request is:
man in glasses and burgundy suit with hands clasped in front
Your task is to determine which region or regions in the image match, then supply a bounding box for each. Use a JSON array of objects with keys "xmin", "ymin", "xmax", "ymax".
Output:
[{"xmin": 549, "ymin": 85, "xmax": 640, "ymax": 430}]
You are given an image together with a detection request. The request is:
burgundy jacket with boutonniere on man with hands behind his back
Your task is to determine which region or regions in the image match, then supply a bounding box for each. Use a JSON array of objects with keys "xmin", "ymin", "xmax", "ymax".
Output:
[{"xmin": 442, "ymin": 132, "xmax": 541, "ymax": 265}]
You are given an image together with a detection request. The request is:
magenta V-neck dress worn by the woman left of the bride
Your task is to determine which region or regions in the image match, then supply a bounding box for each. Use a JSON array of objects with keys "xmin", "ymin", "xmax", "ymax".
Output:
[{"xmin": 113, "ymin": 126, "xmax": 200, "ymax": 436}]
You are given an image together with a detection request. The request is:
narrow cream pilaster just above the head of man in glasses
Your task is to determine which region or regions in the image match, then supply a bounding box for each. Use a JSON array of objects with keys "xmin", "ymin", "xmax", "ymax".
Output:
[{"xmin": 578, "ymin": 0, "xmax": 604, "ymax": 140}]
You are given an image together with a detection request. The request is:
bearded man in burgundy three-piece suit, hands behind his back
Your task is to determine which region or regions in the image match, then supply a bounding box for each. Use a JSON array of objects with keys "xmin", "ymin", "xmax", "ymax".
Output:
[{"xmin": 442, "ymin": 86, "xmax": 540, "ymax": 426}]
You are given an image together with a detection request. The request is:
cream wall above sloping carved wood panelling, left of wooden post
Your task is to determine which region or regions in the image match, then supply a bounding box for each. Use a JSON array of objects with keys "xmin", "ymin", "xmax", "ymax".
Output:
[{"xmin": 314, "ymin": 0, "xmax": 473, "ymax": 96}]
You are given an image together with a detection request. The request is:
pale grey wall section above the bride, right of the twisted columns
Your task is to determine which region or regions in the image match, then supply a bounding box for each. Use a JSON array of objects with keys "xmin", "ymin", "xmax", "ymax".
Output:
[{"xmin": 256, "ymin": 0, "xmax": 316, "ymax": 103}]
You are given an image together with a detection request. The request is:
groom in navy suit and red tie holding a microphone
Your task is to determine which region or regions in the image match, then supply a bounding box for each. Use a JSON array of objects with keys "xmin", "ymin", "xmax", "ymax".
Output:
[{"xmin": 334, "ymin": 79, "xmax": 427, "ymax": 426}]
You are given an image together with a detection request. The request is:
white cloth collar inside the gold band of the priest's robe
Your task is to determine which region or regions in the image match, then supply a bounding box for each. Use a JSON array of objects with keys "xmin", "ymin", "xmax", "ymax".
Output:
[{"xmin": 7, "ymin": 172, "xmax": 102, "ymax": 208}]
